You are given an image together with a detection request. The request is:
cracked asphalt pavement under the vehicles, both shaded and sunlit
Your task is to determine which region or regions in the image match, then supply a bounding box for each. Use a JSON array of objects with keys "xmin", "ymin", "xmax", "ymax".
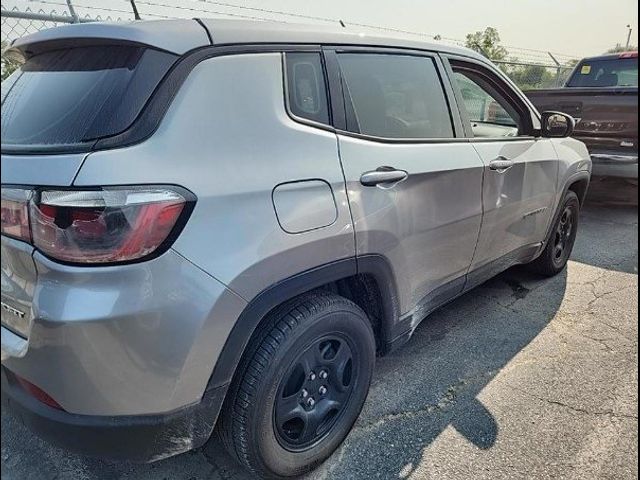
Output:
[{"xmin": 2, "ymin": 178, "xmax": 638, "ymax": 480}]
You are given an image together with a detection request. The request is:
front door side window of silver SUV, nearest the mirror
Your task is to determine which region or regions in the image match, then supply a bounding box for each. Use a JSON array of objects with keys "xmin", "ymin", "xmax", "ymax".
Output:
[{"xmin": 454, "ymin": 68, "xmax": 521, "ymax": 138}]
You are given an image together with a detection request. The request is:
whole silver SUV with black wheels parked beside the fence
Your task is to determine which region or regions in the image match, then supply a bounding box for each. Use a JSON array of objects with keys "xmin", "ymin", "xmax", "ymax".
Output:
[{"xmin": 2, "ymin": 20, "xmax": 591, "ymax": 478}]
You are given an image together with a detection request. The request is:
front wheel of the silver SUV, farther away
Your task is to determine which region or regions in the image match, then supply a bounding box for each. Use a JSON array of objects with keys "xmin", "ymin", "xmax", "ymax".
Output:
[{"xmin": 529, "ymin": 191, "xmax": 580, "ymax": 277}]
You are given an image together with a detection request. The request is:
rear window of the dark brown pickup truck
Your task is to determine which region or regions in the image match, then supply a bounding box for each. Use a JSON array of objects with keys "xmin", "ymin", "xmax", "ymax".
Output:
[{"xmin": 567, "ymin": 58, "xmax": 638, "ymax": 87}]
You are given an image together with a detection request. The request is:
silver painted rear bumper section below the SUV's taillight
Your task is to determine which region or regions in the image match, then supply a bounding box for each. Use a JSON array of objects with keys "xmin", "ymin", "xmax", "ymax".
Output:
[{"xmin": 2, "ymin": 244, "xmax": 246, "ymax": 417}]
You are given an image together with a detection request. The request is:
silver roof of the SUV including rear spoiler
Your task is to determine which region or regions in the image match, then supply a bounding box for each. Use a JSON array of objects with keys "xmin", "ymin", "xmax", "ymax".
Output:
[{"xmin": 11, "ymin": 18, "xmax": 486, "ymax": 61}]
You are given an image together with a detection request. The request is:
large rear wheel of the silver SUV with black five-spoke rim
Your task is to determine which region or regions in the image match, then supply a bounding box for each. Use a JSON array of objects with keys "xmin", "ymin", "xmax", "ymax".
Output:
[{"xmin": 219, "ymin": 292, "xmax": 376, "ymax": 478}]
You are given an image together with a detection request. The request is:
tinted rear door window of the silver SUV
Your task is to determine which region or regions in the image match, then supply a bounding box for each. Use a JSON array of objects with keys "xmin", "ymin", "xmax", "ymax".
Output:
[{"xmin": 338, "ymin": 53, "xmax": 453, "ymax": 139}]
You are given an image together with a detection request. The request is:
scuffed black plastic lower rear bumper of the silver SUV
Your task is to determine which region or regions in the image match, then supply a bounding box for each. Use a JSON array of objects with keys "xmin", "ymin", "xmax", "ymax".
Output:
[{"xmin": 2, "ymin": 367, "xmax": 226, "ymax": 463}]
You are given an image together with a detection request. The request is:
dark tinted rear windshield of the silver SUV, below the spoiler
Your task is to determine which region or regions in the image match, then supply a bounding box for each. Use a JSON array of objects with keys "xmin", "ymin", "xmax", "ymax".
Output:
[{"xmin": 2, "ymin": 46, "xmax": 177, "ymax": 150}]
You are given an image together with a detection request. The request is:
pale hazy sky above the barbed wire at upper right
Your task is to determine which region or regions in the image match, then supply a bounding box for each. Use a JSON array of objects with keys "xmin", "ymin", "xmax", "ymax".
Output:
[{"xmin": 219, "ymin": 0, "xmax": 638, "ymax": 57}]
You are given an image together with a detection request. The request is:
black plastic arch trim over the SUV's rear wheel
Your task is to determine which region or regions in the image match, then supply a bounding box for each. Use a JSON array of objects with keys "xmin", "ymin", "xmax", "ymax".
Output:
[{"xmin": 207, "ymin": 255, "xmax": 400, "ymax": 390}]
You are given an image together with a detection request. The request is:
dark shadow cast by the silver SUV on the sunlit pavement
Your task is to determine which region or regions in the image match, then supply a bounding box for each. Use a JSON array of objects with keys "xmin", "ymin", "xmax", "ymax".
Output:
[{"xmin": 302, "ymin": 268, "xmax": 567, "ymax": 479}]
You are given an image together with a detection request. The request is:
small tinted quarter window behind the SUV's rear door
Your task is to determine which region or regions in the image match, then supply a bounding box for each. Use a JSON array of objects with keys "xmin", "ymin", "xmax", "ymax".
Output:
[{"xmin": 286, "ymin": 53, "xmax": 329, "ymax": 124}]
